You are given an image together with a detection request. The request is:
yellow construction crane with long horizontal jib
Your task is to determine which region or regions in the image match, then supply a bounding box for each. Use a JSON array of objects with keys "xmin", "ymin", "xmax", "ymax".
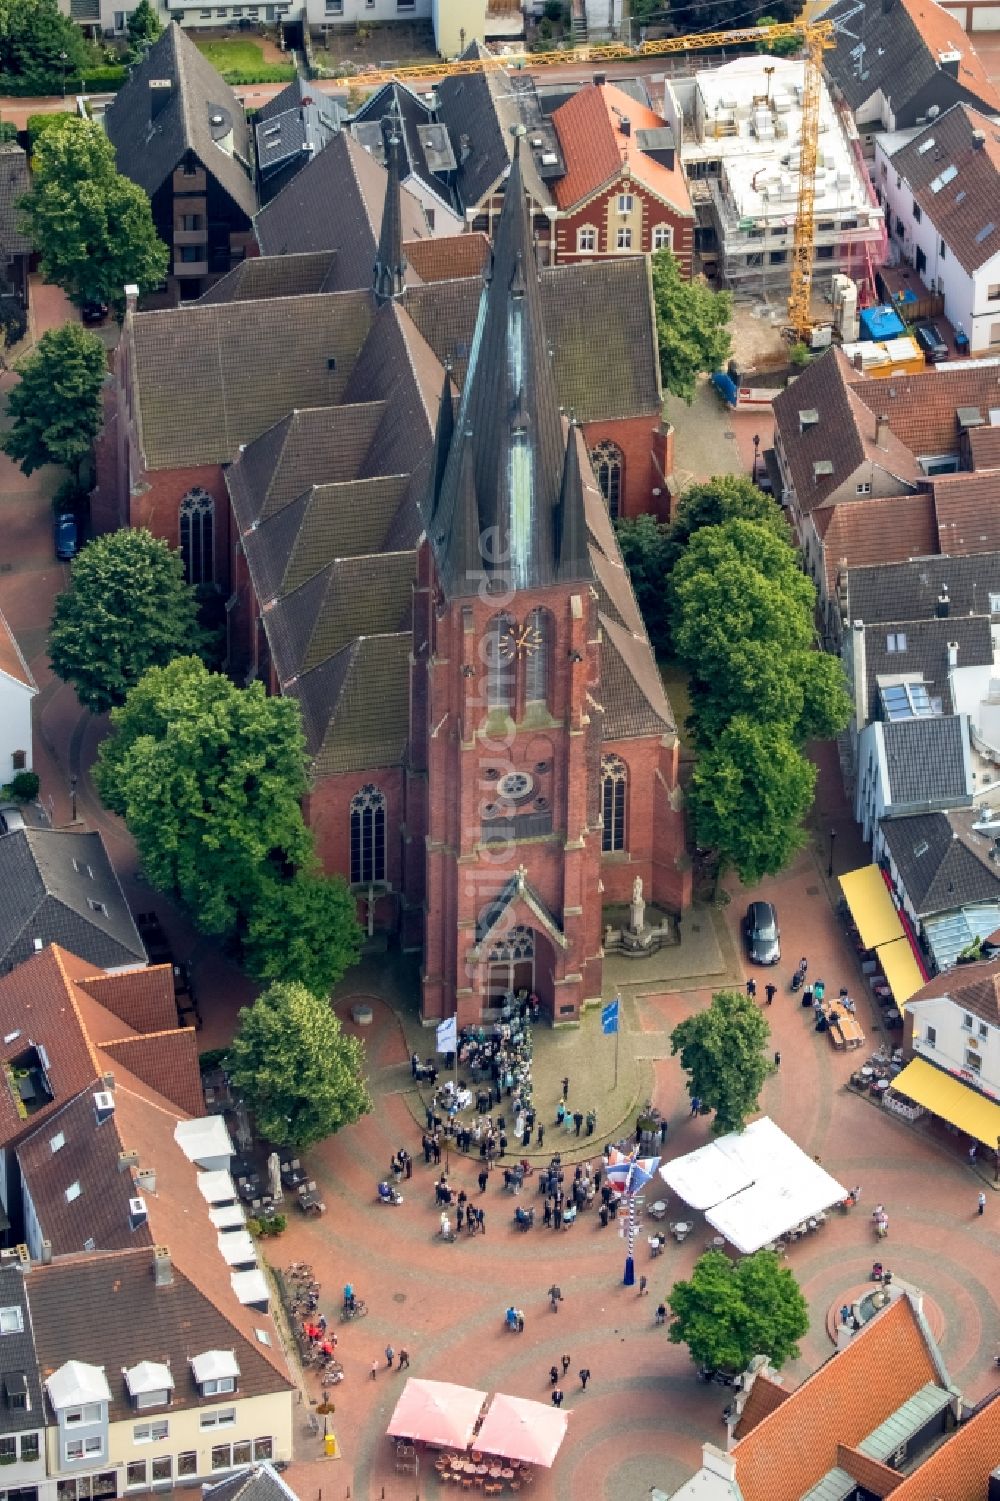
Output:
[{"xmin": 346, "ymin": 17, "xmax": 835, "ymax": 338}]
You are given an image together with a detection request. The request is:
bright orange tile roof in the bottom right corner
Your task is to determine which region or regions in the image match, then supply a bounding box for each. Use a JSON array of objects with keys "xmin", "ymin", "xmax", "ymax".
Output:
[{"xmin": 731, "ymin": 1297, "xmax": 944, "ymax": 1501}]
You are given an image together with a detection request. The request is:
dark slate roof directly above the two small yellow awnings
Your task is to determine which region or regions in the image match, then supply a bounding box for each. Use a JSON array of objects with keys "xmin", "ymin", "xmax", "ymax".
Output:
[{"xmin": 880, "ymin": 812, "xmax": 1000, "ymax": 917}]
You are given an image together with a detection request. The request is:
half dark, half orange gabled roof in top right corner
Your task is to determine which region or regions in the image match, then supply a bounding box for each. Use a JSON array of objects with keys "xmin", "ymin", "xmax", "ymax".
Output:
[{"xmin": 823, "ymin": 0, "xmax": 997, "ymax": 126}]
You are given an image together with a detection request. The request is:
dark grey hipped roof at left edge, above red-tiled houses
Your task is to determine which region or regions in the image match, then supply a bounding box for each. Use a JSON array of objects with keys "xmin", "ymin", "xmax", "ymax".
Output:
[{"xmin": 0, "ymin": 829, "xmax": 147, "ymax": 973}]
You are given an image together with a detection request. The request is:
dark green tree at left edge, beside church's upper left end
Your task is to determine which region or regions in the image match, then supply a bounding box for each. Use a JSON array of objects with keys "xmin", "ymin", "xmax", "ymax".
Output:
[{"xmin": 0, "ymin": 323, "xmax": 108, "ymax": 474}]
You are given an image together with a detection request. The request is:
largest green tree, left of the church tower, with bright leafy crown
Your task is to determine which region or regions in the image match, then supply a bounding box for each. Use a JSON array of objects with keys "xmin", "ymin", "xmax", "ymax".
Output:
[{"xmin": 95, "ymin": 656, "xmax": 312, "ymax": 934}]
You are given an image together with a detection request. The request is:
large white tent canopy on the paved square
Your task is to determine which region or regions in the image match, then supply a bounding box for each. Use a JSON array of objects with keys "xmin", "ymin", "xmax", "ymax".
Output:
[{"xmin": 659, "ymin": 1115, "xmax": 847, "ymax": 1255}]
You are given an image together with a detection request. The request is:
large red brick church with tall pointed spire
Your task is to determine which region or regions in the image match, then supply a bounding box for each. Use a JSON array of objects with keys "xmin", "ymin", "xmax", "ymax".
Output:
[{"xmin": 105, "ymin": 129, "xmax": 691, "ymax": 1024}]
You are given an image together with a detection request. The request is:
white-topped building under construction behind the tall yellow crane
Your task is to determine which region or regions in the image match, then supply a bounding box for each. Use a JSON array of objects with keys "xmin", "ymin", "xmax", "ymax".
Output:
[{"xmin": 676, "ymin": 56, "xmax": 884, "ymax": 296}]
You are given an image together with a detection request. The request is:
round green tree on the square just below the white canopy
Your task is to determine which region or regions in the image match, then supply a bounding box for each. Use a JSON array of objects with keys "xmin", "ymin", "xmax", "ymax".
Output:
[{"xmin": 667, "ymin": 1250, "xmax": 809, "ymax": 1375}]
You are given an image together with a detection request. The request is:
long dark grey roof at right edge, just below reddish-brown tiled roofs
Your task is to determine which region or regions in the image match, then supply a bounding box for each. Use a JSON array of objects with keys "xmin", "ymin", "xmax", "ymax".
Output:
[{"xmin": 844, "ymin": 552, "xmax": 1000, "ymax": 626}]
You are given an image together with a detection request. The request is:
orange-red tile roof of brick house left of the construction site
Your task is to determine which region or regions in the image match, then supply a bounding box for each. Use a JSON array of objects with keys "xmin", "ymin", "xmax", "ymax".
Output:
[{"xmin": 553, "ymin": 84, "xmax": 694, "ymax": 216}]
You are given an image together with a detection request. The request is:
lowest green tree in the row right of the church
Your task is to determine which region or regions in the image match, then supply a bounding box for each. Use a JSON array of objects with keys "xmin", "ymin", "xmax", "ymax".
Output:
[{"xmin": 688, "ymin": 714, "xmax": 815, "ymax": 886}]
